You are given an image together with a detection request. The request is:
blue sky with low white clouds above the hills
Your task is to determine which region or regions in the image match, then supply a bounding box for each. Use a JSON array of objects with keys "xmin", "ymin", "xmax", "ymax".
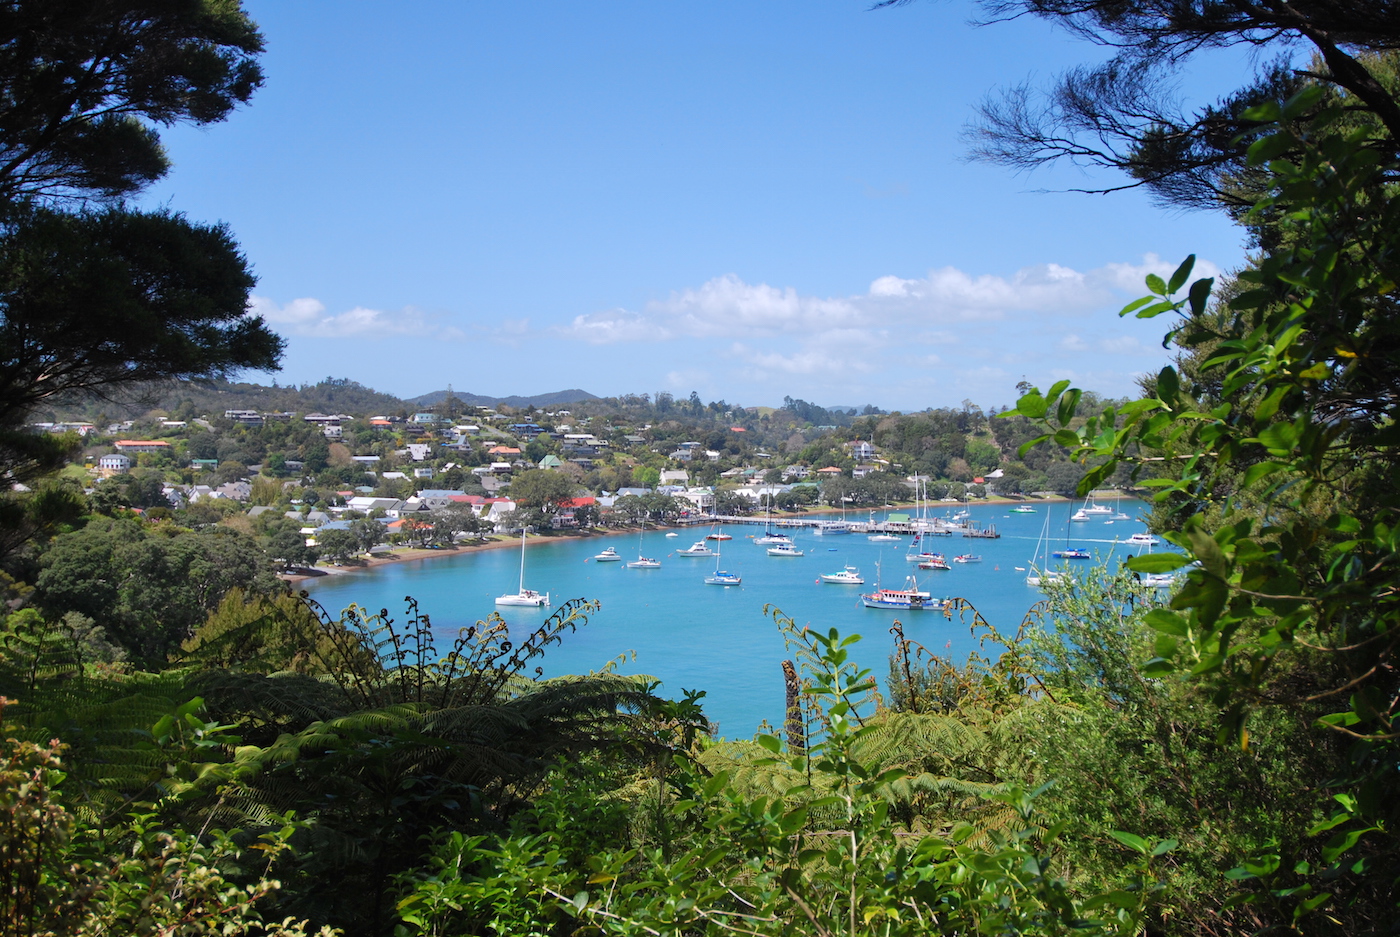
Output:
[{"xmin": 147, "ymin": 0, "xmax": 1260, "ymax": 410}]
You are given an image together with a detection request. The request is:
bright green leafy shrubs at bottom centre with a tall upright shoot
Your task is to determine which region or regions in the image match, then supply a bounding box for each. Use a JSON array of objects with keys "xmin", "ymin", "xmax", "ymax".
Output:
[{"xmin": 398, "ymin": 616, "xmax": 1173, "ymax": 937}]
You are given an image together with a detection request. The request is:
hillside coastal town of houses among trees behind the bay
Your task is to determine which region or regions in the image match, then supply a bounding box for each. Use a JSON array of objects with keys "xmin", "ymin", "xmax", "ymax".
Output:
[{"xmin": 31, "ymin": 378, "xmax": 1125, "ymax": 573}]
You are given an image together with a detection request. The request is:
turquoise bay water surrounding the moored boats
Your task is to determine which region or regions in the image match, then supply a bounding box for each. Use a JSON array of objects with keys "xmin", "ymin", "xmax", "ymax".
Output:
[{"xmin": 307, "ymin": 500, "xmax": 1145, "ymax": 738}]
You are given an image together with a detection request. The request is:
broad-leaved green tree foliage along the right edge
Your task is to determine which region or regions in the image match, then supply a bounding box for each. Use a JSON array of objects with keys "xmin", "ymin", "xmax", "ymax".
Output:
[{"xmin": 1018, "ymin": 100, "xmax": 1400, "ymax": 926}]
